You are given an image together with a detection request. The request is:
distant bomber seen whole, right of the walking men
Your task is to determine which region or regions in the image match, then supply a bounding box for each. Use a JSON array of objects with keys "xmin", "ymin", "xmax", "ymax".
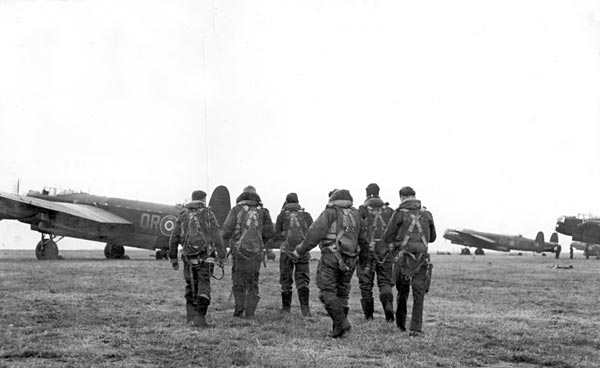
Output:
[{"xmin": 444, "ymin": 229, "xmax": 559, "ymax": 255}]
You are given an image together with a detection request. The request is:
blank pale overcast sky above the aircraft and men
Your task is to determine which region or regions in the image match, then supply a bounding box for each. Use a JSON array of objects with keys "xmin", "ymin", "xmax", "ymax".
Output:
[{"xmin": 0, "ymin": 0, "xmax": 600, "ymax": 249}]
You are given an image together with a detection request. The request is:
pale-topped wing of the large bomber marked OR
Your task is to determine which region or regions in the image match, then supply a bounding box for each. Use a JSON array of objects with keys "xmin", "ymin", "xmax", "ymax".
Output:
[{"xmin": 0, "ymin": 193, "xmax": 131, "ymax": 225}]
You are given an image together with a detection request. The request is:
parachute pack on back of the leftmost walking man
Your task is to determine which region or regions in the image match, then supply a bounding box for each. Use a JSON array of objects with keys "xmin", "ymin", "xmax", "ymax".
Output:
[{"xmin": 181, "ymin": 208, "xmax": 212, "ymax": 257}]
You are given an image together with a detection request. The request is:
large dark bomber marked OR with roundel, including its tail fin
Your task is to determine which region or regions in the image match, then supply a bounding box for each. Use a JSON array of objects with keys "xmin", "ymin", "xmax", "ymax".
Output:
[{"xmin": 0, "ymin": 186, "xmax": 230, "ymax": 259}]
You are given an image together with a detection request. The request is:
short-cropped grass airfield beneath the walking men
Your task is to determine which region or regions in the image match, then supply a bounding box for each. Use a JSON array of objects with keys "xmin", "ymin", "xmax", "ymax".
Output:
[{"xmin": 0, "ymin": 250, "xmax": 600, "ymax": 367}]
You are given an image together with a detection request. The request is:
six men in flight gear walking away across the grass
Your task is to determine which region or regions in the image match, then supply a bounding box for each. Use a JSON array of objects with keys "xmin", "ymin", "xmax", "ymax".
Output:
[{"xmin": 169, "ymin": 184, "xmax": 436, "ymax": 338}]
